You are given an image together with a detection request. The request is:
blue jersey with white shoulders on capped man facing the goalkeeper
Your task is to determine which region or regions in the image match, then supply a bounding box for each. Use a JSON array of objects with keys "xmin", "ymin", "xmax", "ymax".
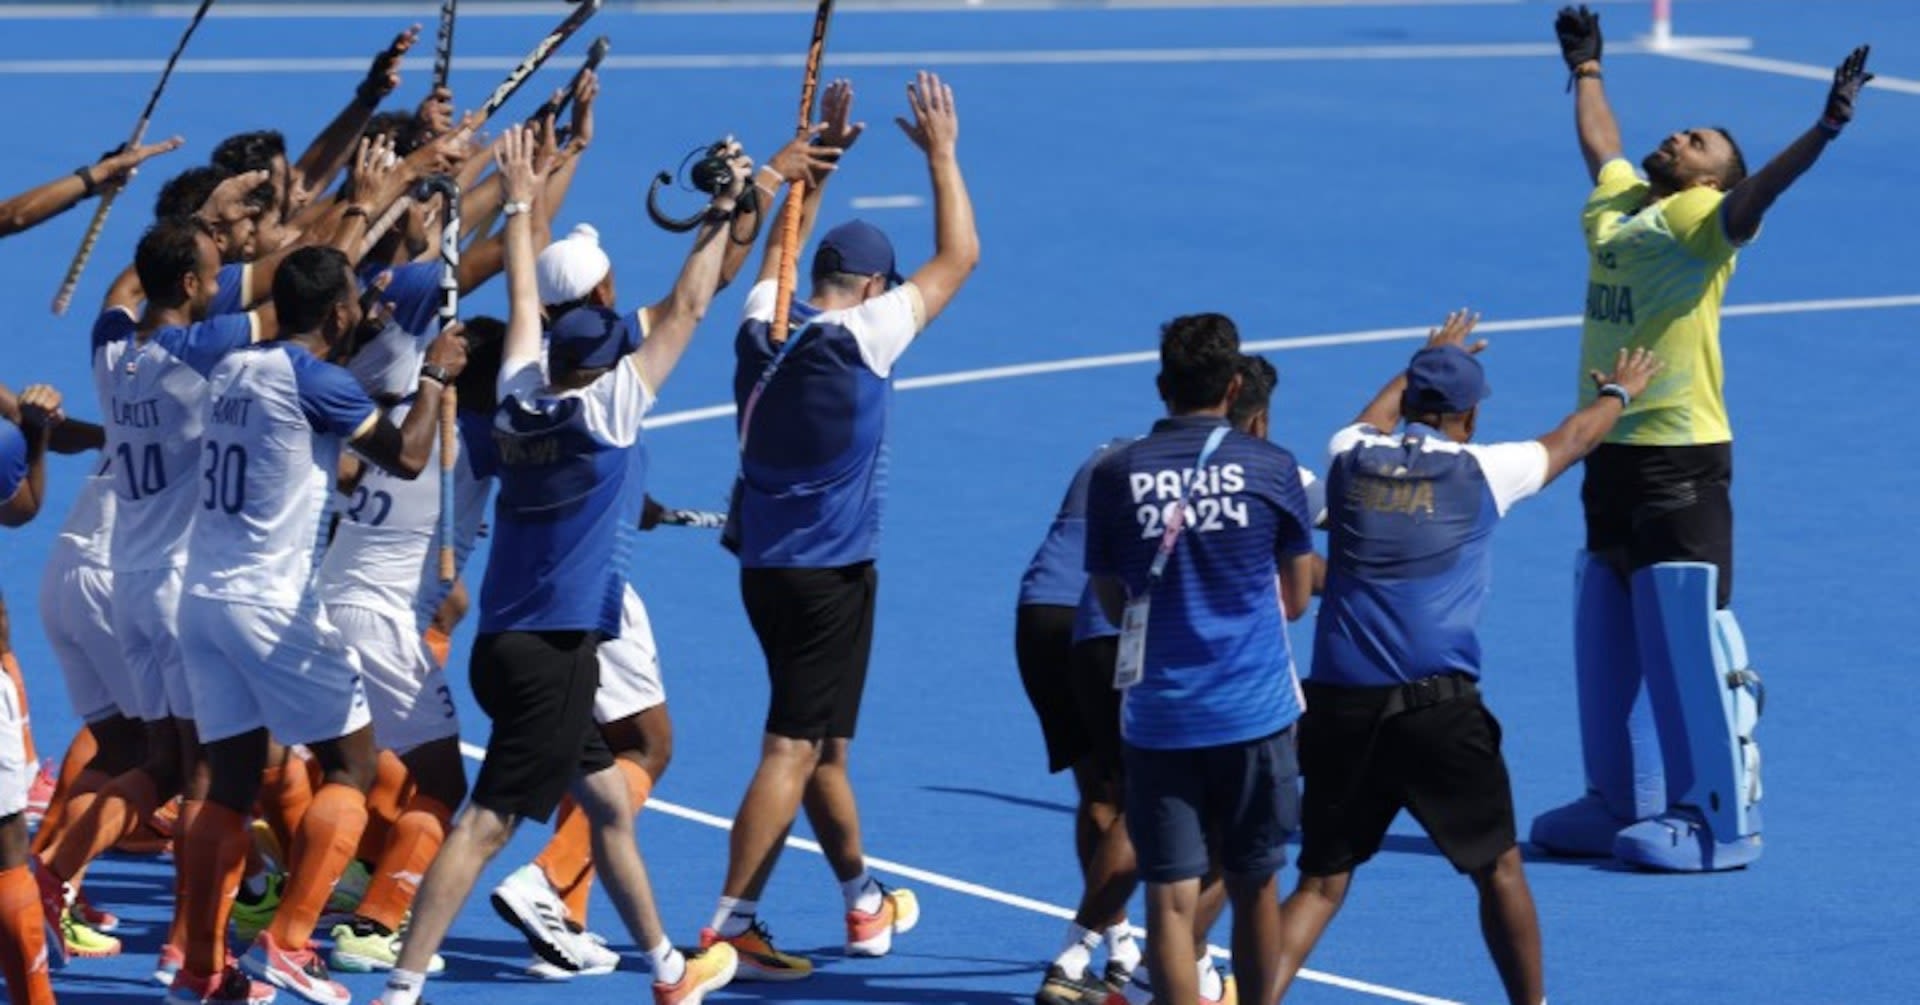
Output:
[{"xmin": 1311, "ymin": 425, "xmax": 1548, "ymax": 686}]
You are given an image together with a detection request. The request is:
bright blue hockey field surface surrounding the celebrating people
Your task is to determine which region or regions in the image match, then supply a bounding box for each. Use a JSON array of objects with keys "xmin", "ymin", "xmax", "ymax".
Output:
[{"xmin": 0, "ymin": 0, "xmax": 1920, "ymax": 1005}]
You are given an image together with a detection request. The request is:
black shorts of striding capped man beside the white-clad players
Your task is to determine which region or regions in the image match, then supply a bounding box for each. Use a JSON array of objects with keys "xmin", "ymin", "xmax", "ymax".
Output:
[{"xmin": 468, "ymin": 632, "xmax": 612, "ymax": 822}]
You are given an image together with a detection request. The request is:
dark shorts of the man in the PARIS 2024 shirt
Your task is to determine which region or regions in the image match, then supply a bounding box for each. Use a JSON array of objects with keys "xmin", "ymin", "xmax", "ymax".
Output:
[{"xmin": 1125, "ymin": 728, "xmax": 1300, "ymax": 882}]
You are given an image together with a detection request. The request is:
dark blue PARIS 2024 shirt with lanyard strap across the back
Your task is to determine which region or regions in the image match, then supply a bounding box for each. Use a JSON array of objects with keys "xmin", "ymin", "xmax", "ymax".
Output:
[{"xmin": 1087, "ymin": 415, "xmax": 1313, "ymax": 749}]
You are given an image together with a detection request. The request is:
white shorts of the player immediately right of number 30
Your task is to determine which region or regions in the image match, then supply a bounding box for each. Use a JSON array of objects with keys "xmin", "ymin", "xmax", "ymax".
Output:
[{"xmin": 326, "ymin": 603, "xmax": 461, "ymax": 753}]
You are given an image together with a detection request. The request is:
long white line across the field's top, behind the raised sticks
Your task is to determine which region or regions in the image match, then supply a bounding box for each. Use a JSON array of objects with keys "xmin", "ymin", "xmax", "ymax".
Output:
[{"xmin": 0, "ymin": 40, "xmax": 1758, "ymax": 83}]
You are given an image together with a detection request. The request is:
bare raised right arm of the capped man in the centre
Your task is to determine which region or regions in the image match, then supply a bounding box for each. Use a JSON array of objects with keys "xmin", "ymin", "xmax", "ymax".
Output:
[{"xmin": 895, "ymin": 71, "xmax": 979, "ymax": 325}]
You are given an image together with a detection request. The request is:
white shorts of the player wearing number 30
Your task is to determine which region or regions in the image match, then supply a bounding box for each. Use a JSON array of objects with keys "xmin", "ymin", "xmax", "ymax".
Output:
[{"xmin": 180, "ymin": 596, "xmax": 372, "ymax": 746}]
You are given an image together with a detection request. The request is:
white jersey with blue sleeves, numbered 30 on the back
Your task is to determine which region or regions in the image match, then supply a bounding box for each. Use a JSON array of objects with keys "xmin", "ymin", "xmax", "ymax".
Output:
[{"xmin": 185, "ymin": 340, "xmax": 380, "ymax": 607}]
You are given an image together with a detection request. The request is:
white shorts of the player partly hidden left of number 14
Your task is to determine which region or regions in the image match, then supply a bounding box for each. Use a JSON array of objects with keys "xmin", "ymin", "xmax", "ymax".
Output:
[{"xmin": 40, "ymin": 563, "xmax": 129, "ymax": 726}]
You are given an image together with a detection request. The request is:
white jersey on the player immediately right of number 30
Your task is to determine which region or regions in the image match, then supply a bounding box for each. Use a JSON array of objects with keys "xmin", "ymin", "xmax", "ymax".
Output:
[{"xmin": 326, "ymin": 402, "xmax": 457, "ymax": 619}]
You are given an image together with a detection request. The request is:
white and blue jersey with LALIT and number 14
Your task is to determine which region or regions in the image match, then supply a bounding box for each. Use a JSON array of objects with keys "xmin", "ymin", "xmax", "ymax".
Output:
[{"xmin": 94, "ymin": 307, "xmax": 257, "ymax": 573}]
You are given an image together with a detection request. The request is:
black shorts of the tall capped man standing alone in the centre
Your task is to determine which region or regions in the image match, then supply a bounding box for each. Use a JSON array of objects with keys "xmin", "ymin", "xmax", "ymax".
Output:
[{"xmin": 739, "ymin": 561, "xmax": 879, "ymax": 740}]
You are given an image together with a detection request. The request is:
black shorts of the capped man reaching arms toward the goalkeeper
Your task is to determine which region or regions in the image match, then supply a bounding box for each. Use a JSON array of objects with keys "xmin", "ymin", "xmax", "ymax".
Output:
[{"xmin": 1300, "ymin": 682, "xmax": 1515, "ymax": 876}]
